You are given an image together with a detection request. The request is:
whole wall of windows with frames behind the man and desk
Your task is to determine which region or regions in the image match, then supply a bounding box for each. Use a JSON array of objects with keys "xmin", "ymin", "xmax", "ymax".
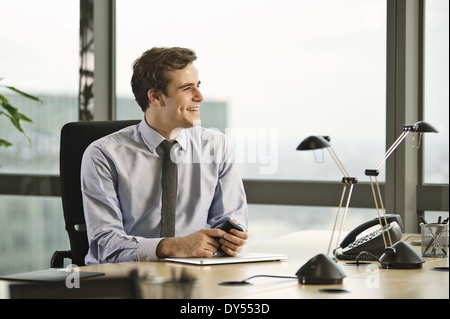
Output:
[{"xmin": 0, "ymin": 0, "xmax": 449, "ymax": 275}]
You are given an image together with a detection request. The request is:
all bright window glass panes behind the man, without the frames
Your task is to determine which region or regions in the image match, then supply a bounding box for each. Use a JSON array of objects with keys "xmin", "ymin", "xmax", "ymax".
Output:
[{"xmin": 0, "ymin": 0, "xmax": 449, "ymax": 274}]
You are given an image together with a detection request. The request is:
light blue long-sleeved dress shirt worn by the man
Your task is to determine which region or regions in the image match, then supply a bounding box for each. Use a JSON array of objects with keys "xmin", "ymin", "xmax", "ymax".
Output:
[{"xmin": 81, "ymin": 120, "xmax": 248, "ymax": 265}]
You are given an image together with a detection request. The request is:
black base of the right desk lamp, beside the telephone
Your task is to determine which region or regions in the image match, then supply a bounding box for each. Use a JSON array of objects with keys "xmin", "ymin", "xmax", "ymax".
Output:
[{"xmin": 379, "ymin": 241, "xmax": 425, "ymax": 269}]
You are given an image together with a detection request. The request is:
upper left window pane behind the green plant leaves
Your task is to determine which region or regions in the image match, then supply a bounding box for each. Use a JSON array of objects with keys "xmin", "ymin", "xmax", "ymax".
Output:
[{"xmin": 0, "ymin": 0, "xmax": 79, "ymax": 174}]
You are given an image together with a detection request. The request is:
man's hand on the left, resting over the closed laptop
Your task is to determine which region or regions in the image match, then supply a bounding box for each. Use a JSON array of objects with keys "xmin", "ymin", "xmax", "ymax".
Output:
[{"xmin": 156, "ymin": 229, "xmax": 227, "ymax": 258}]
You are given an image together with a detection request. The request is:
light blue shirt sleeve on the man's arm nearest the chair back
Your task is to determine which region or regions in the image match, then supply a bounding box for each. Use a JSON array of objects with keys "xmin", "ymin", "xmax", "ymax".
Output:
[{"xmin": 81, "ymin": 144, "xmax": 162, "ymax": 264}]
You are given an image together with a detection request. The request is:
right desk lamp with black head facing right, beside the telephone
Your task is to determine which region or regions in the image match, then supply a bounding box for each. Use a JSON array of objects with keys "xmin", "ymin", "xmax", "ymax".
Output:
[{"xmin": 365, "ymin": 122, "xmax": 438, "ymax": 269}]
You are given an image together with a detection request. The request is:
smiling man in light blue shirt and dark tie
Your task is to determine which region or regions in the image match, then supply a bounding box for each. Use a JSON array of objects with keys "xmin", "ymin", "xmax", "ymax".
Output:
[{"xmin": 81, "ymin": 48, "xmax": 248, "ymax": 264}]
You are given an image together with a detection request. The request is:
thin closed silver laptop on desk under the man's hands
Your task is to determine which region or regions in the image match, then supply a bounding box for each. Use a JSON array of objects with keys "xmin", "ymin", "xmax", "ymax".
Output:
[{"xmin": 164, "ymin": 253, "xmax": 288, "ymax": 265}]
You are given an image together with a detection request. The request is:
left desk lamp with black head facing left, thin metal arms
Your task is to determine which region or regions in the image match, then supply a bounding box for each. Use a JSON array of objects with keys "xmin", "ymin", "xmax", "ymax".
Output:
[{"xmin": 296, "ymin": 136, "xmax": 357, "ymax": 284}]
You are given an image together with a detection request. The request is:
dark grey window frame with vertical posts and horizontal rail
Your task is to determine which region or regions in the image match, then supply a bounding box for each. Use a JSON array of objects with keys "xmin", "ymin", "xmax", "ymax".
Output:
[{"xmin": 0, "ymin": 0, "xmax": 449, "ymax": 232}]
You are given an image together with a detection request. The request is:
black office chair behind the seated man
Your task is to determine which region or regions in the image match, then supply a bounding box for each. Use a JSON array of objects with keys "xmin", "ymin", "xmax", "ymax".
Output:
[{"xmin": 50, "ymin": 120, "xmax": 140, "ymax": 268}]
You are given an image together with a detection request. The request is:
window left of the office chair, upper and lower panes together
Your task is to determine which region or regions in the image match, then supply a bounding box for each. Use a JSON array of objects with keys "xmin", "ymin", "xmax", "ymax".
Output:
[{"xmin": 0, "ymin": 0, "xmax": 80, "ymax": 275}]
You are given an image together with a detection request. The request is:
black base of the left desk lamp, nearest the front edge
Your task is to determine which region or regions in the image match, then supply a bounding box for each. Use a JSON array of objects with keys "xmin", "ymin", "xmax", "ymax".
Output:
[{"xmin": 295, "ymin": 254, "xmax": 346, "ymax": 285}]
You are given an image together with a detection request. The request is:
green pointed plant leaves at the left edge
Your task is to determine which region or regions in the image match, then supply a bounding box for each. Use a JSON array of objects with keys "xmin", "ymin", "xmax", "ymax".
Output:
[{"xmin": 0, "ymin": 78, "xmax": 42, "ymax": 147}]
